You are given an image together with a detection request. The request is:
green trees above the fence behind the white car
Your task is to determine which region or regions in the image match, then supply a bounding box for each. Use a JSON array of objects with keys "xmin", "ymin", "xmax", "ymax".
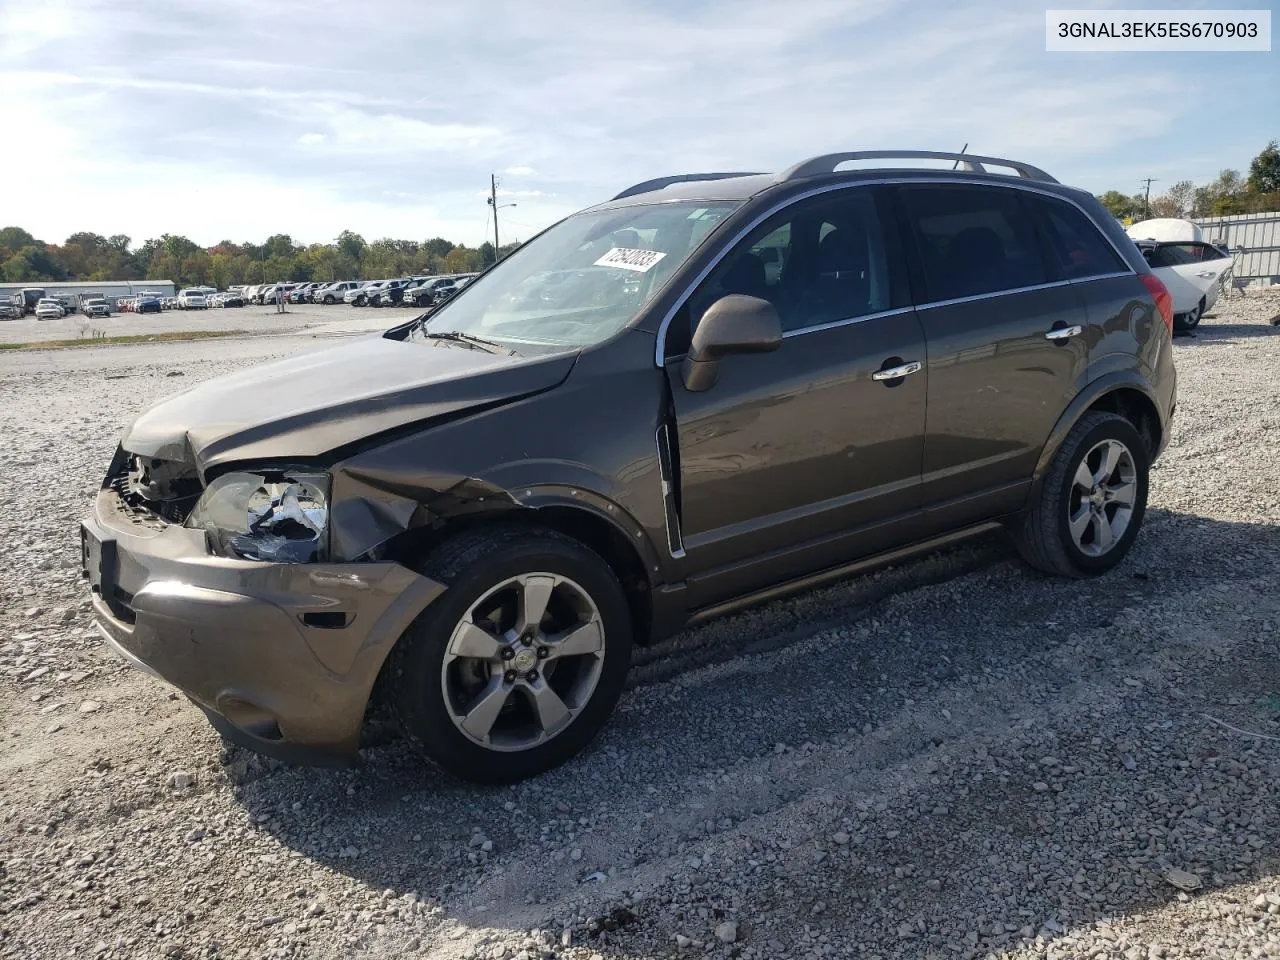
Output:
[{"xmin": 1098, "ymin": 141, "xmax": 1280, "ymax": 220}]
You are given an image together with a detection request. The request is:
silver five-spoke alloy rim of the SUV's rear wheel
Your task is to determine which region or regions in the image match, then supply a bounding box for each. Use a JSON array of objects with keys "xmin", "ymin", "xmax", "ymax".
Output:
[{"xmin": 1068, "ymin": 439, "xmax": 1138, "ymax": 557}]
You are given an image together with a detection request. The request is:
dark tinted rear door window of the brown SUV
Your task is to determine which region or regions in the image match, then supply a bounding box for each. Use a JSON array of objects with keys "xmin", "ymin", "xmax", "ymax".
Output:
[{"xmin": 900, "ymin": 184, "xmax": 1048, "ymax": 302}]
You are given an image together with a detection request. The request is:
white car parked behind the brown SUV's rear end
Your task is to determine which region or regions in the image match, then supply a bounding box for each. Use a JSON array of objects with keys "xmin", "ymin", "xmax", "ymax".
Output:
[{"xmin": 1128, "ymin": 219, "xmax": 1233, "ymax": 332}]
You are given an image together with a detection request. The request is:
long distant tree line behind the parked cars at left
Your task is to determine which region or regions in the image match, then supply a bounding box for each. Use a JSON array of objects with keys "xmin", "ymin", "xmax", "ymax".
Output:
[{"xmin": 0, "ymin": 227, "xmax": 520, "ymax": 289}]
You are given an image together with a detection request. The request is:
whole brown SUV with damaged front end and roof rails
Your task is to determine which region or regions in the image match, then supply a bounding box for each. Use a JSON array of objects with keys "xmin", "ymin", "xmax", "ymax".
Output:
[{"xmin": 83, "ymin": 152, "xmax": 1175, "ymax": 781}]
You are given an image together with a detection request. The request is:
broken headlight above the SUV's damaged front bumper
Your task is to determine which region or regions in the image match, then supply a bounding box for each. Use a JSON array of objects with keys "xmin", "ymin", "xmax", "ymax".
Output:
[{"xmin": 187, "ymin": 470, "xmax": 329, "ymax": 563}]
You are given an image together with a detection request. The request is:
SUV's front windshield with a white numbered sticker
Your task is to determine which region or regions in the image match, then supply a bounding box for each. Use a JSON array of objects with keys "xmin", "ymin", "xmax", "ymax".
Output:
[{"xmin": 410, "ymin": 201, "xmax": 739, "ymax": 352}]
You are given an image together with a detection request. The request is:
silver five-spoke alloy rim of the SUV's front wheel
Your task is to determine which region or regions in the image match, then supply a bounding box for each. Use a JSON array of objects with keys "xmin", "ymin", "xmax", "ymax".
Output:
[{"xmin": 440, "ymin": 573, "xmax": 604, "ymax": 753}]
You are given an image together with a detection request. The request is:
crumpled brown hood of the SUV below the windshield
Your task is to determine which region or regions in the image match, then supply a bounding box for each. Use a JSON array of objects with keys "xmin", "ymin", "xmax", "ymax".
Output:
[{"xmin": 122, "ymin": 337, "xmax": 577, "ymax": 475}]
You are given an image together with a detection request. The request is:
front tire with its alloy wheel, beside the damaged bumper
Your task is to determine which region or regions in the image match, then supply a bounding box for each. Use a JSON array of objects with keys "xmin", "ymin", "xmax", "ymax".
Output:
[{"xmin": 388, "ymin": 527, "xmax": 631, "ymax": 783}]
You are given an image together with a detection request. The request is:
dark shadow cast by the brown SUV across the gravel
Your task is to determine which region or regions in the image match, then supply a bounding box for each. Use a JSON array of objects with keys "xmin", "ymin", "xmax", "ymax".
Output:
[{"xmin": 227, "ymin": 509, "xmax": 1280, "ymax": 956}]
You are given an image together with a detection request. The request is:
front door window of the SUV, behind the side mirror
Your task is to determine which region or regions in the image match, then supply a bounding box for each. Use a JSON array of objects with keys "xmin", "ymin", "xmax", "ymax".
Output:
[{"xmin": 667, "ymin": 188, "xmax": 892, "ymax": 356}]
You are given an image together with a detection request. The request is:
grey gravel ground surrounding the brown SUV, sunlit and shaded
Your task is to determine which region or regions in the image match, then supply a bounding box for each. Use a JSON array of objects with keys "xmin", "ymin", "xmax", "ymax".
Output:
[{"xmin": 0, "ymin": 293, "xmax": 1280, "ymax": 960}]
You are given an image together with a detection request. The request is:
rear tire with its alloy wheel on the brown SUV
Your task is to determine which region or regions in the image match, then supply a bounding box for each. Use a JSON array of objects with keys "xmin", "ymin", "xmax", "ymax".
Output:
[{"xmin": 1018, "ymin": 411, "xmax": 1151, "ymax": 577}]
